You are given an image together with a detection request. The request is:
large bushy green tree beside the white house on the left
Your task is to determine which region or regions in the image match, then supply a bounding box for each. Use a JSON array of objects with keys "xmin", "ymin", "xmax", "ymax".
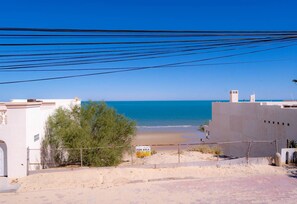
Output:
[{"xmin": 43, "ymin": 102, "xmax": 136, "ymax": 166}]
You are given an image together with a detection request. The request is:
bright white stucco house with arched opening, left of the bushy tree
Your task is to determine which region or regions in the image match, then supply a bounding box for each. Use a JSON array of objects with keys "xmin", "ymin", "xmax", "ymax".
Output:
[{"xmin": 0, "ymin": 98, "xmax": 81, "ymax": 178}]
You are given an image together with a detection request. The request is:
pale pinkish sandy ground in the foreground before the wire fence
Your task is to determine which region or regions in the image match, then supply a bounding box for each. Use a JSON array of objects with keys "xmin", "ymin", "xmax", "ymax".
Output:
[{"xmin": 0, "ymin": 165, "xmax": 297, "ymax": 203}]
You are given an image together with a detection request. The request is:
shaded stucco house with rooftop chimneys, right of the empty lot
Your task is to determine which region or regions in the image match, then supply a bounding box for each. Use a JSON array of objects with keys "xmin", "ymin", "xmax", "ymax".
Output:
[{"xmin": 205, "ymin": 90, "xmax": 297, "ymax": 157}]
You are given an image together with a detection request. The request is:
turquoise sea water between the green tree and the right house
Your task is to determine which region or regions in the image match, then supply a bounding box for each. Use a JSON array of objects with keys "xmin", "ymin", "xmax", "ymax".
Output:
[{"xmin": 106, "ymin": 101, "xmax": 213, "ymax": 127}]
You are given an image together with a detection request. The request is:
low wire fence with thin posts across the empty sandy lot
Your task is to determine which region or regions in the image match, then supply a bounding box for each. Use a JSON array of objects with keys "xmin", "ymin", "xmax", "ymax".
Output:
[{"xmin": 27, "ymin": 140, "xmax": 278, "ymax": 172}]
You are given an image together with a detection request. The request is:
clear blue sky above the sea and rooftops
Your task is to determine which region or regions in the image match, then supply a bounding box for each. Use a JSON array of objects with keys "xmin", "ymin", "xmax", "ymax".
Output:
[{"xmin": 0, "ymin": 0, "xmax": 297, "ymax": 101}]
